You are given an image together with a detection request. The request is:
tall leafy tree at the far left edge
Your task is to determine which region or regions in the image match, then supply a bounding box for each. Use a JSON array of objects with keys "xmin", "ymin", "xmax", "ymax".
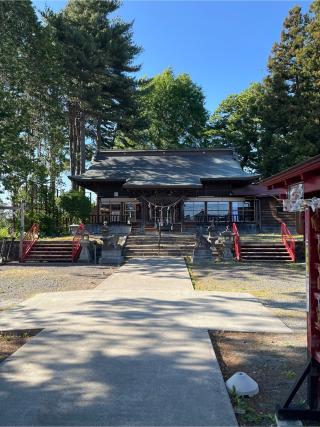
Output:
[{"xmin": 0, "ymin": 0, "xmax": 65, "ymax": 227}]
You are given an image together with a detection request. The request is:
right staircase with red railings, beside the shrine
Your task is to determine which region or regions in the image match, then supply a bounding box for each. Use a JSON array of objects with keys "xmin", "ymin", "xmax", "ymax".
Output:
[{"xmin": 241, "ymin": 240, "xmax": 292, "ymax": 262}]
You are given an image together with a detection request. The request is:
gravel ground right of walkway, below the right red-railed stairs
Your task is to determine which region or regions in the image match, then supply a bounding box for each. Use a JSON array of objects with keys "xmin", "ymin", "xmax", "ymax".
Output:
[{"xmin": 190, "ymin": 263, "xmax": 306, "ymax": 332}]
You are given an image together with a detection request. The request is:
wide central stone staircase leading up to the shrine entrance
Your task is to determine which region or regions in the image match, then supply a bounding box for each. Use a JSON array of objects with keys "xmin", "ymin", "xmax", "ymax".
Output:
[{"xmin": 124, "ymin": 233, "xmax": 195, "ymax": 259}]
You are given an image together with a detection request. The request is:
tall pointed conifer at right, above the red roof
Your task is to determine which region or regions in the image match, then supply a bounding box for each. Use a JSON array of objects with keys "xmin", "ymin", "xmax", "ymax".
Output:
[{"xmin": 259, "ymin": 6, "xmax": 315, "ymax": 175}]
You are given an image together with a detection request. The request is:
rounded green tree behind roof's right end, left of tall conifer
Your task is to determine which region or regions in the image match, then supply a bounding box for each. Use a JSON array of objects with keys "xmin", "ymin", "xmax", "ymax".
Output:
[{"xmin": 207, "ymin": 83, "xmax": 263, "ymax": 170}]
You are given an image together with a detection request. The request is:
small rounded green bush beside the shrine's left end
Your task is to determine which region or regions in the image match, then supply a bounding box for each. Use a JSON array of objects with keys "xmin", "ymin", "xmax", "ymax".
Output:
[{"xmin": 59, "ymin": 191, "xmax": 91, "ymax": 221}]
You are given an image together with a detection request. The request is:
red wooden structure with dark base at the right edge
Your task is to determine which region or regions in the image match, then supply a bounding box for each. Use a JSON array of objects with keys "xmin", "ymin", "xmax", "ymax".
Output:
[{"xmin": 262, "ymin": 155, "xmax": 320, "ymax": 420}]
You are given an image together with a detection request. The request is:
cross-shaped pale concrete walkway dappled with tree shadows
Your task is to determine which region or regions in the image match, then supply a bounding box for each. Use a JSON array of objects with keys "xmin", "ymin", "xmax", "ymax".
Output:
[{"xmin": 0, "ymin": 258, "xmax": 290, "ymax": 426}]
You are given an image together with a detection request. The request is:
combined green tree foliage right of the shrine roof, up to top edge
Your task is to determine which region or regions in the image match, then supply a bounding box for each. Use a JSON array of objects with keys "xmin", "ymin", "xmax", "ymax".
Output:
[{"xmin": 207, "ymin": 0, "xmax": 320, "ymax": 176}]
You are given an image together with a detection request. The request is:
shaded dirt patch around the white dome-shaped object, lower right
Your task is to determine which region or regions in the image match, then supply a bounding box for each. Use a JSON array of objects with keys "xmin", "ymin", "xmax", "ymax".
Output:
[{"xmin": 210, "ymin": 331, "xmax": 307, "ymax": 426}]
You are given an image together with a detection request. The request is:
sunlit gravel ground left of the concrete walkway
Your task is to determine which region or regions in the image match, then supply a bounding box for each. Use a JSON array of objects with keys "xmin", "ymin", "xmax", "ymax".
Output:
[{"xmin": 0, "ymin": 263, "xmax": 115, "ymax": 310}]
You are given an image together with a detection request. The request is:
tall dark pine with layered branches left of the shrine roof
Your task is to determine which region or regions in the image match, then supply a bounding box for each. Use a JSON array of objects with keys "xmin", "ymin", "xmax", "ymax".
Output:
[{"xmin": 44, "ymin": 0, "xmax": 140, "ymax": 188}]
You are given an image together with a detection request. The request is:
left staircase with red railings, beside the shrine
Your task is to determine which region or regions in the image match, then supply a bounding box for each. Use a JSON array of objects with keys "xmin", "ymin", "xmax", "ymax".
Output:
[{"xmin": 25, "ymin": 240, "xmax": 72, "ymax": 262}]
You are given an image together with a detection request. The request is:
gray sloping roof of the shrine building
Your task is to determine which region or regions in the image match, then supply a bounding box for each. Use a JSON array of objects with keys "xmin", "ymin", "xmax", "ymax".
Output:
[{"xmin": 70, "ymin": 149, "xmax": 258, "ymax": 188}]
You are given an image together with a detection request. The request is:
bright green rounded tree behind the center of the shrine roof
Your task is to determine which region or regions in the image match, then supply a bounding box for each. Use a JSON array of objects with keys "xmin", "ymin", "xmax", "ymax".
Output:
[{"xmin": 131, "ymin": 69, "xmax": 208, "ymax": 149}]
